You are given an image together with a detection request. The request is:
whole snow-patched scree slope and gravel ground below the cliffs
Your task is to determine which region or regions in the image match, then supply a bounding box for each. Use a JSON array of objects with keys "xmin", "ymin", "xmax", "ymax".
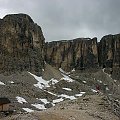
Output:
[{"xmin": 0, "ymin": 64, "xmax": 120, "ymax": 120}]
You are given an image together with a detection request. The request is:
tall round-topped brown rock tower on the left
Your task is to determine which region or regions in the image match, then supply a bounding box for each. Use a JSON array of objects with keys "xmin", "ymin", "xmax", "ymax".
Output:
[{"xmin": 0, "ymin": 14, "xmax": 44, "ymax": 75}]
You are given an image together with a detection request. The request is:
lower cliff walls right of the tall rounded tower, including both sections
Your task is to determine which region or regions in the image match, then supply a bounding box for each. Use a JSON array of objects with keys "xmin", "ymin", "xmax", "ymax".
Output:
[{"xmin": 45, "ymin": 34, "xmax": 120, "ymax": 79}]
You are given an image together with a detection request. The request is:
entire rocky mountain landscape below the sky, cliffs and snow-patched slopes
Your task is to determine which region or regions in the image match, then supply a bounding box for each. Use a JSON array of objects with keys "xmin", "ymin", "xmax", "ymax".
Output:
[{"xmin": 0, "ymin": 14, "xmax": 120, "ymax": 120}]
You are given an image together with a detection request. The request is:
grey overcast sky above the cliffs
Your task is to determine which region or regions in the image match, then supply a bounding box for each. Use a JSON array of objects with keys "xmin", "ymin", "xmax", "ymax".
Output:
[{"xmin": 0, "ymin": 0, "xmax": 120, "ymax": 41}]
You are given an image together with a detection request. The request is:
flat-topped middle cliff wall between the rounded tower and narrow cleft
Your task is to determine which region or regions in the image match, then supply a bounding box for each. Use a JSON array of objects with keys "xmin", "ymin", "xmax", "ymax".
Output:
[{"xmin": 45, "ymin": 38, "xmax": 98, "ymax": 71}]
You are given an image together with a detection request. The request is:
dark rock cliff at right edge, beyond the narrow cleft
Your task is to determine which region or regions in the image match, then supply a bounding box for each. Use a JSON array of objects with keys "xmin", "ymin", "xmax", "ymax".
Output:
[{"xmin": 98, "ymin": 34, "xmax": 120, "ymax": 79}]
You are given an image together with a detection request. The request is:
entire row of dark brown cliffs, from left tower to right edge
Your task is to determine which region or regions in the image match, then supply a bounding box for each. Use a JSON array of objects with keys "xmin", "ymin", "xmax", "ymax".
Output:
[{"xmin": 0, "ymin": 14, "xmax": 120, "ymax": 78}]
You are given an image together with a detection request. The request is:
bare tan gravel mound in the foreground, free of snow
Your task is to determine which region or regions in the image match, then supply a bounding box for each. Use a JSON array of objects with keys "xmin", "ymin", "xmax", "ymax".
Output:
[{"xmin": 1, "ymin": 95, "xmax": 119, "ymax": 120}]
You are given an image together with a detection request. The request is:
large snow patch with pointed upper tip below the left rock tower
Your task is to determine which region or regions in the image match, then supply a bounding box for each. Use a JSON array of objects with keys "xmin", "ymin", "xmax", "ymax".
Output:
[{"xmin": 29, "ymin": 72, "xmax": 50, "ymax": 89}]
